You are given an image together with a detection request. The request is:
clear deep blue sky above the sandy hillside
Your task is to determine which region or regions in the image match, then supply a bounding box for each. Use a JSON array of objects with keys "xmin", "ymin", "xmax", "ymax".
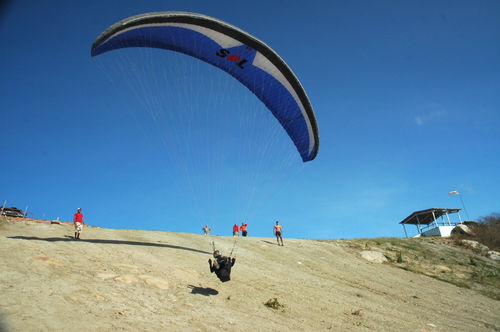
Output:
[{"xmin": 0, "ymin": 0, "xmax": 500, "ymax": 239}]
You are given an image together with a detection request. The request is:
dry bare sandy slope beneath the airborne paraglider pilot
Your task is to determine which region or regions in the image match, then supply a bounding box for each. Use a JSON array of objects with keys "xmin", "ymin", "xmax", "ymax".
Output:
[{"xmin": 0, "ymin": 218, "xmax": 500, "ymax": 331}]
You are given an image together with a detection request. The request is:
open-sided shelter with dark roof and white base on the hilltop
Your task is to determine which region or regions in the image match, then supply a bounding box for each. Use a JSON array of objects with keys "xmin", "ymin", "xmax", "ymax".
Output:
[{"xmin": 400, "ymin": 208, "xmax": 462, "ymax": 237}]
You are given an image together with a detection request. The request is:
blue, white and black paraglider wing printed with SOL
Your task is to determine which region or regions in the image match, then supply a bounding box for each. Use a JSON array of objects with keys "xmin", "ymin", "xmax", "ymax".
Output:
[{"xmin": 91, "ymin": 12, "xmax": 319, "ymax": 162}]
